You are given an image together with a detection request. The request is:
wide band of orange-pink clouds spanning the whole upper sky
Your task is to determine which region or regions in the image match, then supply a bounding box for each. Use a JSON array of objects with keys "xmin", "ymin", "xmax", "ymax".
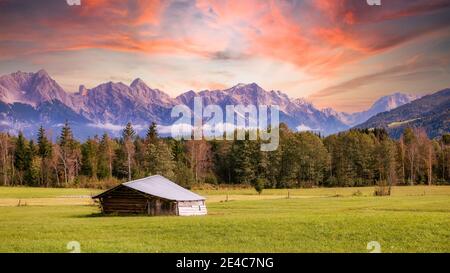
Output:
[{"xmin": 0, "ymin": 0, "xmax": 450, "ymax": 73}]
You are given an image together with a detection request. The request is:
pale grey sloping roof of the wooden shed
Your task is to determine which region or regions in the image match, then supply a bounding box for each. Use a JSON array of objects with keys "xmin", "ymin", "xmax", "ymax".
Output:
[{"xmin": 93, "ymin": 175, "xmax": 206, "ymax": 201}]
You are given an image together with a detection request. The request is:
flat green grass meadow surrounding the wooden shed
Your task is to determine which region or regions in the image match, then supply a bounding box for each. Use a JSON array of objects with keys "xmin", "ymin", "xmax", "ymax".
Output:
[{"xmin": 0, "ymin": 186, "xmax": 450, "ymax": 252}]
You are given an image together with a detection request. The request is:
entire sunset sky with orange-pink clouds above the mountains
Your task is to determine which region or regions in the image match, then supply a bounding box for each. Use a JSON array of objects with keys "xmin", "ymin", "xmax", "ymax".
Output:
[{"xmin": 0, "ymin": 0, "xmax": 450, "ymax": 112}]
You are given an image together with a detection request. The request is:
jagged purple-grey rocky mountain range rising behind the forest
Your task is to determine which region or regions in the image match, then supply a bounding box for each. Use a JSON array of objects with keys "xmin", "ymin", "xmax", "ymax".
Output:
[{"xmin": 0, "ymin": 70, "xmax": 432, "ymax": 139}]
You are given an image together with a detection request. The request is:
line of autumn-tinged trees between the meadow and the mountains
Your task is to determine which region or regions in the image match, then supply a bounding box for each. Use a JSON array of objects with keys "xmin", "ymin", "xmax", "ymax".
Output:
[{"xmin": 0, "ymin": 122, "xmax": 450, "ymax": 190}]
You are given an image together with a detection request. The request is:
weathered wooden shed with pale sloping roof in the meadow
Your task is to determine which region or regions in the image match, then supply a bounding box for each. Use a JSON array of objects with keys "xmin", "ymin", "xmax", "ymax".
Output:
[{"xmin": 92, "ymin": 175, "xmax": 207, "ymax": 216}]
